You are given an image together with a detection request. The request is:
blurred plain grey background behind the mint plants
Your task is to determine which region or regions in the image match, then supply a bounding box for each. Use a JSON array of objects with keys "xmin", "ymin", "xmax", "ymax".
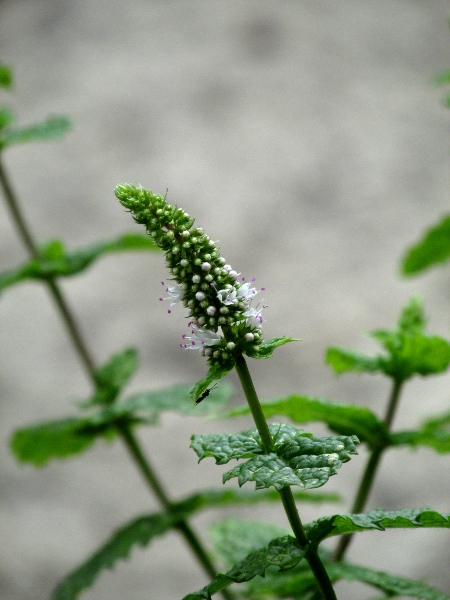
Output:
[{"xmin": 0, "ymin": 0, "xmax": 450, "ymax": 600}]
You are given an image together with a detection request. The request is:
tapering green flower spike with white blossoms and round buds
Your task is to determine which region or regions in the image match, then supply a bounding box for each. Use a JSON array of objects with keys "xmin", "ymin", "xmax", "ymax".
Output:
[{"xmin": 115, "ymin": 184, "xmax": 265, "ymax": 365}]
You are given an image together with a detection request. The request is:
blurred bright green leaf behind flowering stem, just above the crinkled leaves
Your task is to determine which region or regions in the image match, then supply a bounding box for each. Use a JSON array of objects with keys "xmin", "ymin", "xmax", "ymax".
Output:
[{"xmin": 227, "ymin": 394, "xmax": 390, "ymax": 448}]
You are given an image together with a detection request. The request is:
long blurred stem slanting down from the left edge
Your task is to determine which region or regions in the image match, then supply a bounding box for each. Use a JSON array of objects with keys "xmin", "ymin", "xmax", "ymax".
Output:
[{"xmin": 0, "ymin": 153, "xmax": 232, "ymax": 600}]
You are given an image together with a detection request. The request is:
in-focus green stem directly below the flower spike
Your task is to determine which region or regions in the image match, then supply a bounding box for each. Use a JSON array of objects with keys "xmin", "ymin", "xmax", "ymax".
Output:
[{"xmin": 236, "ymin": 355, "xmax": 336, "ymax": 600}]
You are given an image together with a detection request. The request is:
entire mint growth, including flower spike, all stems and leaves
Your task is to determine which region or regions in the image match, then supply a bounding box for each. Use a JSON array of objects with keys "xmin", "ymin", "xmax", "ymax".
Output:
[{"xmin": 0, "ymin": 62, "xmax": 450, "ymax": 600}]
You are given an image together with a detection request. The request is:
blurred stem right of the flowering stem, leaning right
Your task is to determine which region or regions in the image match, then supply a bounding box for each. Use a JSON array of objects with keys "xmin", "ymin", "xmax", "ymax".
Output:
[{"xmin": 333, "ymin": 379, "xmax": 404, "ymax": 561}]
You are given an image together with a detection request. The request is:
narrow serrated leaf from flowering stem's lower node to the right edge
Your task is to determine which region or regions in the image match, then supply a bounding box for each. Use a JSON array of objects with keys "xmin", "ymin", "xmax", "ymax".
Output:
[{"xmin": 306, "ymin": 508, "xmax": 450, "ymax": 544}]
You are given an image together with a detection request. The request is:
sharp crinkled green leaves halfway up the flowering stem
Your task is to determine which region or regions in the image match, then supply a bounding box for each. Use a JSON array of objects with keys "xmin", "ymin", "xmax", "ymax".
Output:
[{"xmin": 191, "ymin": 423, "xmax": 358, "ymax": 490}]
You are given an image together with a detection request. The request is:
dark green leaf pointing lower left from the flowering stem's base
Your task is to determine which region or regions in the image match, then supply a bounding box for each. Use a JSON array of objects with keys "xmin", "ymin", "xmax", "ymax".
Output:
[{"xmin": 183, "ymin": 535, "xmax": 305, "ymax": 600}]
